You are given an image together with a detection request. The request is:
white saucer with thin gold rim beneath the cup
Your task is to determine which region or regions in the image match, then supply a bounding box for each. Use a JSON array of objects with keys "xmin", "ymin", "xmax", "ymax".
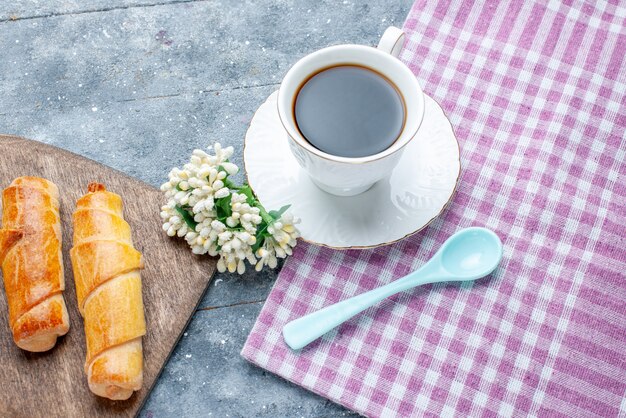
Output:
[{"xmin": 243, "ymin": 92, "xmax": 461, "ymax": 249}]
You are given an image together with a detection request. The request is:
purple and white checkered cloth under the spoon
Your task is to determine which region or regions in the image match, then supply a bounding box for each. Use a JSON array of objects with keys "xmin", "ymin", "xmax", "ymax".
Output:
[{"xmin": 242, "ymin": 0, "xmax": 626, "ymax": 417}]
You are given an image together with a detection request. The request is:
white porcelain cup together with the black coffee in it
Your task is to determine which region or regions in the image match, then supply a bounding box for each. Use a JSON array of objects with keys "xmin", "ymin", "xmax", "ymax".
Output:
[{"xmin": 278, "ymin": 27, "xmax": 424, "ymax": 196}]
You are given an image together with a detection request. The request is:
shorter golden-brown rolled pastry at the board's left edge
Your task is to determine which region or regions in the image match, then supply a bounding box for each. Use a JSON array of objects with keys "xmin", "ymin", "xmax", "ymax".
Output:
[{"xmin": 0, "ymin": 177, "xmax": 70, "ymax": 352}]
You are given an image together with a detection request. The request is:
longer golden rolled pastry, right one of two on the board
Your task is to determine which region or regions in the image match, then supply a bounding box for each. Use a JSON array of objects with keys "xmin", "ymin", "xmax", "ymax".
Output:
[{"xmin": 70, "ymin": 183, "xmax": 146, "ymax": 400}]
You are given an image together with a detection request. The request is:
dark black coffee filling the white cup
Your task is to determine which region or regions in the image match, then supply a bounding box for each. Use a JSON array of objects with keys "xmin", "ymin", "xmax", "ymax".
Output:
[{"xmin": 294, "ymin": 65, "xmax": 405, "ymax": 157}]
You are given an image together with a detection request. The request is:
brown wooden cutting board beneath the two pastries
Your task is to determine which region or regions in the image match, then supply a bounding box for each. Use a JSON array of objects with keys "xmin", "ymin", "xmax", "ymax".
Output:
[{"xmin": 0, "ymin": 135, "xmax": 215, "ymax": 417}]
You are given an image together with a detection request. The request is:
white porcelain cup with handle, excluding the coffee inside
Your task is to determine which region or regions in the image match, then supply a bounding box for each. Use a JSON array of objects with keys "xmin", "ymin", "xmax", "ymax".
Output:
[{"xmin": 278, "ymin": 26, "xmax": 424, "ymax": 196}]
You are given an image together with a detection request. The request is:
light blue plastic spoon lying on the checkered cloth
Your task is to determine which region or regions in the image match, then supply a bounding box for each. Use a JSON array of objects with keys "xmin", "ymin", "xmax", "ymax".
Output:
[{"xmin": 283, "ymin": 227, "xmax": 502, "ymax": 350}]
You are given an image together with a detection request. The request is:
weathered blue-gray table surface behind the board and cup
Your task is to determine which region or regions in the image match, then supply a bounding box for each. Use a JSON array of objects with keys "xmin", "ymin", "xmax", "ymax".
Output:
[{"xmin": 0, "ymin": 0, "xmax": 412, "ymax": 417}]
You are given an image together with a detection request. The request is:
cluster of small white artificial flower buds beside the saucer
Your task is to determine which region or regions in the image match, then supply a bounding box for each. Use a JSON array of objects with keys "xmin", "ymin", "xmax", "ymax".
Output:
[{"xmin": 161, "ymin": 143, "xmax": 299, "ymax": 274}]
